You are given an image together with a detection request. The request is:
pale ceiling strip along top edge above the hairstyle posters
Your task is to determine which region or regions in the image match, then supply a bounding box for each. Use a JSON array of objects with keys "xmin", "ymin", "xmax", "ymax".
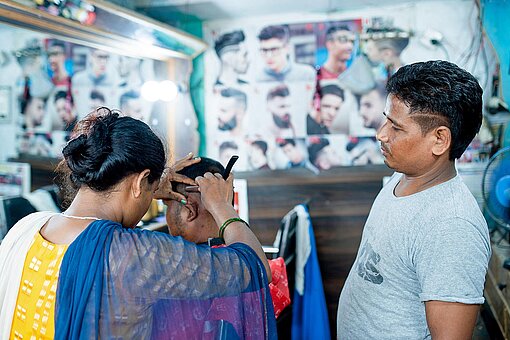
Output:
[{"xmin": 134, "ymin": 0, "xmax": 426, "ymax": 20}]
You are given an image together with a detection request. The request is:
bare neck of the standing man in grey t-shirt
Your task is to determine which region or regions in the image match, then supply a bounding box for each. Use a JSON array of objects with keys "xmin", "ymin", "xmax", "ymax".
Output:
[{"xmin": 395, "ymin": 160, "xmax": 457, "ymax": 197}]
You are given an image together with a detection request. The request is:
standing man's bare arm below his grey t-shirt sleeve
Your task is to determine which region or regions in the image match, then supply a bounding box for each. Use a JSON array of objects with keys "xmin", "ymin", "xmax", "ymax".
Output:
[{"xmin": 425, "ymin": 301, "xmax": 480, "ymax": 340}]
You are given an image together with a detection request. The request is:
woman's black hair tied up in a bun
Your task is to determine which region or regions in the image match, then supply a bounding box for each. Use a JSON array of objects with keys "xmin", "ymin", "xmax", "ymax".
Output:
[{"xmin": 59, "ymin": 108, "xmax": 166, "ymax": 191}]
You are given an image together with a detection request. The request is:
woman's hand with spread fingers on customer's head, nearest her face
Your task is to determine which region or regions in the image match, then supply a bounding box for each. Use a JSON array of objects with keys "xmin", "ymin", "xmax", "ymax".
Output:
[{"xmin": 154, "ymin": 152, "xmax": 201, "ymax": 201}]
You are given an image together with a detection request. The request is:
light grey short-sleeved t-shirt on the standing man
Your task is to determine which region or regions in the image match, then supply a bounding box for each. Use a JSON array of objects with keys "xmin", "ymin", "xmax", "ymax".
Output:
[{"xmin": 337, "ymin": 174, "xmax": 491, "ymax": 340}]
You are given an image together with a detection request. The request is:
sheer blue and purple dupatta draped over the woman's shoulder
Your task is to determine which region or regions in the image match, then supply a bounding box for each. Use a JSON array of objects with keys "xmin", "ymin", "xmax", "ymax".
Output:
[{"xmin": 55, "ymin": 221, "xmax": 276, "ymax": 339}]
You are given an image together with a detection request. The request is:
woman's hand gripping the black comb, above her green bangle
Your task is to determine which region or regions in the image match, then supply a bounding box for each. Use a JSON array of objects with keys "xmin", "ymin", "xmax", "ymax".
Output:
[{"xmin": 195, "ymin": 172, "xmax": 234, "ymax": 216}]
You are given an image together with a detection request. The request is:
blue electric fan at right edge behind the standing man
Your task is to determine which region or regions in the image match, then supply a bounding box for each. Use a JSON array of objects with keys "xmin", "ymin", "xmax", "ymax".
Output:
[{"xmin": 482, "ymin": 147, "xmax": 510, "ymax": 239}]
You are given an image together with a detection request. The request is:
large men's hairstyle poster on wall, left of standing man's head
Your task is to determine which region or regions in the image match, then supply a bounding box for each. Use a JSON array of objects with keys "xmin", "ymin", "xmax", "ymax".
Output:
[{"xmin": 205, "ymin": 5, "xmax": 493, "ymax": 173}]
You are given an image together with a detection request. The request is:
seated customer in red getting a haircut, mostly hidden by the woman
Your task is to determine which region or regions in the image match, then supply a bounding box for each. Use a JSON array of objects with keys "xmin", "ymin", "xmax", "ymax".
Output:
[{"xmin": 163, "ymin": 157, "xmax": 290, "ymax": 317}]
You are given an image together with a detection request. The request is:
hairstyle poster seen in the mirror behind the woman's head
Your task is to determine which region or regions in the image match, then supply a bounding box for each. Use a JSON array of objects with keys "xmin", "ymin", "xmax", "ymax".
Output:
[{"xmin": 0, "ymin": 27, "xmax": 171, "ymax": 157}]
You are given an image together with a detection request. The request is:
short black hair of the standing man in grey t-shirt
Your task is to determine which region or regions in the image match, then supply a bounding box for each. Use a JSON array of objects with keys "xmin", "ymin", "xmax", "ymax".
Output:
[{"xmin": 386, "ymin": 60, "xmax": 483, "ymax": 160}]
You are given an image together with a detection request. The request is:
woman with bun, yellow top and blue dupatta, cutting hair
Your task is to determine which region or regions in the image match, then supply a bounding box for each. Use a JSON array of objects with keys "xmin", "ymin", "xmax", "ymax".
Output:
[{"xmin": 0, "ymin": 108, "xmax": 276, "ymax": 339}]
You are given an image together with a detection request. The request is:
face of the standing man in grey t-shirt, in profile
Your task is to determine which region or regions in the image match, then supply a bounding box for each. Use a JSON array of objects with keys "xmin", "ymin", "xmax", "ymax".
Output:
[{"xmin": 377, "ymin": 94, "xmax": 435, "ymax": 176}]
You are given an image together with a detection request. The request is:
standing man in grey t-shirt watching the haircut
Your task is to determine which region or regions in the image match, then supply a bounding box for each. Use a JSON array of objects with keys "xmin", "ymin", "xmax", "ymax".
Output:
[{"xmin": 337, "ymin": 61, "xmax": 491, "ymax": 340}]
